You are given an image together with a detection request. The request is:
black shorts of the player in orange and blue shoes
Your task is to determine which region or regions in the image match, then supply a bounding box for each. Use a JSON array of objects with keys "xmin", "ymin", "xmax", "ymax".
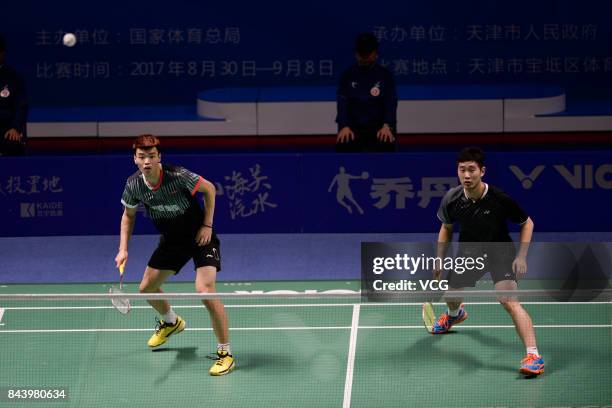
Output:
[{"xmin": 447, "ymin": 244, "xmax": 516, "ymax": 289}]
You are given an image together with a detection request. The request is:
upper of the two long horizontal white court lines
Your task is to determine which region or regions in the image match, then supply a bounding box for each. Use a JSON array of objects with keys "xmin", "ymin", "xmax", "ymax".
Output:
[{"xmin": 4, "ymin": 301, "xmax": 612, "ymax": 310}]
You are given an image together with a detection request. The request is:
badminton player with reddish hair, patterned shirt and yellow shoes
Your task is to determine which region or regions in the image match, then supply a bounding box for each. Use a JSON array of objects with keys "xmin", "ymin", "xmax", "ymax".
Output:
[{"xmin": 115, "ymin": 135, "xmax": 235, "ymax": 375}]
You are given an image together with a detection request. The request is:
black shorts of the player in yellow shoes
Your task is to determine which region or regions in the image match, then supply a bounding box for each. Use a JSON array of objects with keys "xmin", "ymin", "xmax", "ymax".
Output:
[{"xmin": 147, "ymin": 235, "xmax": 221, "ymax": 274}]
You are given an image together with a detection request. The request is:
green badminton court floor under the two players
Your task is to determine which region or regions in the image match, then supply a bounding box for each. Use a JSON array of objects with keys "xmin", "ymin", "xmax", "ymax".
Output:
[{"xmin": 0, "ymin": 281, "xmax": 612, "ymax": 408}]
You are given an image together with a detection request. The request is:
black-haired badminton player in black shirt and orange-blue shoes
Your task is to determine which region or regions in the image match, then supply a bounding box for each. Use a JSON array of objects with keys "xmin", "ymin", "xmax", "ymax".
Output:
[{"xmin": 432, "ymin": 147, "xmax": 544, "ymax": 375}]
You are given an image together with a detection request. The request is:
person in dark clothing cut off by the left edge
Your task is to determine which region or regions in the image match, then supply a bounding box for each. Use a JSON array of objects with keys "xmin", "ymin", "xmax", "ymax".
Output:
[{"xmin": 0, "ymin": 34, "xmax": 28, "ymax": 156}]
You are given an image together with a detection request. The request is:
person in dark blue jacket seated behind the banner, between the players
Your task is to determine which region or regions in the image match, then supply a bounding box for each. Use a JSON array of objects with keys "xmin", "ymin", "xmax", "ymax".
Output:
[{"xmin": 336, "ymin": 33, "xmax": 397, "ymax": 152}]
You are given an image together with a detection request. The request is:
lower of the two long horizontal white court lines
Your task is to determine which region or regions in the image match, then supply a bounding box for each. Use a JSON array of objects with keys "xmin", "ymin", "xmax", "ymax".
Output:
[{"xmin": 0, "ymin": 324, "xmax": 612, "ymax": 334}]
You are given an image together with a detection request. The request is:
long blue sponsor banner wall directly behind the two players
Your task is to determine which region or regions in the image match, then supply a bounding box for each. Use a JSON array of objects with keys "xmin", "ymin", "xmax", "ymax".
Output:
[{"xmin": 0, "ymin": 151, "xmax": 612, "ymax": 236}]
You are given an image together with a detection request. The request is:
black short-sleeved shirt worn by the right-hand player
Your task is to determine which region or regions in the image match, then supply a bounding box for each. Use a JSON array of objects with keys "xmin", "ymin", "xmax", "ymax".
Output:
[{"xmin": 438, "ymin": 184, "xmax": 529, "ymax": 242}]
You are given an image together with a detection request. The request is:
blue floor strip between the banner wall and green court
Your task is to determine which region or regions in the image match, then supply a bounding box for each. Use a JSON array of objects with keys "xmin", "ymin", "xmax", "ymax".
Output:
[{"xmin": 0, "ymin": 233, "xmax": 612, "ymax": 289}]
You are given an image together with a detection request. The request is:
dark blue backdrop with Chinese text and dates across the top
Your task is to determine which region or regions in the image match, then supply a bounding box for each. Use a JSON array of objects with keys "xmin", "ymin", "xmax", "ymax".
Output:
[{"xmin": 2, "ymin": 0, "xmax": 612, "ymax": 107}]
